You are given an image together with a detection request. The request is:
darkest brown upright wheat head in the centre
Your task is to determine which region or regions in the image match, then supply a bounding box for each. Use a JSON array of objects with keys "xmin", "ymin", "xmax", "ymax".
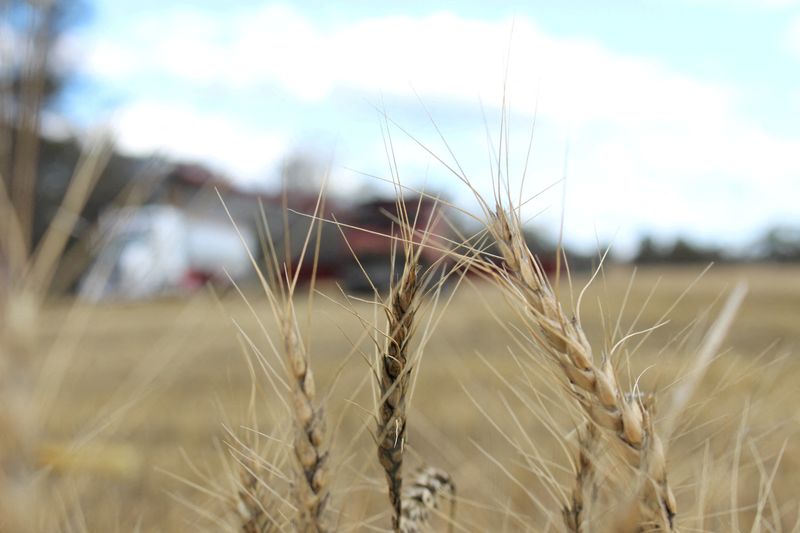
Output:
[{"xmin": 377, "ymin": 255, "xmax": 419, "ymax": 531}]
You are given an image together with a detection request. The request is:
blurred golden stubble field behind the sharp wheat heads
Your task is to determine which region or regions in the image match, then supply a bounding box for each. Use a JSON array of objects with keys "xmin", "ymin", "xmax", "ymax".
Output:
[{"xmin": 39, "ymin": 267, "xmax": 800, "ymax": 531}]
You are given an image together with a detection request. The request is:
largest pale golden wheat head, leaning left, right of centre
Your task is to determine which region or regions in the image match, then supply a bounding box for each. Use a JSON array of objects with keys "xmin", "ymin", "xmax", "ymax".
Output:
[{"xmin": 488, "ymin": 205, "xmax": 676, "ymax": 531}]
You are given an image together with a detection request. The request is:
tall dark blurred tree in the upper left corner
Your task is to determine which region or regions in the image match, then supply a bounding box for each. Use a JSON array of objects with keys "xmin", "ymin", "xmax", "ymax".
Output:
[{"xmin": 0, "ymin": 0, "xmax": 163, "ymax": 290}]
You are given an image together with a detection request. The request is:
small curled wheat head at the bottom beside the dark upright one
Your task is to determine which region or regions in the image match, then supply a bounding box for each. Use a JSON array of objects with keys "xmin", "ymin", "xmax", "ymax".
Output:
[{"xmin": 400, "ymin": 467, "xmax": 456, "ymax": 533}]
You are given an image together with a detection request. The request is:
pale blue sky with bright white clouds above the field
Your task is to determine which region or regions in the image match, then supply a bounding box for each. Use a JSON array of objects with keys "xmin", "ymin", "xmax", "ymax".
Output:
[{"xmin": 54, "ymin": 0, "xmax": 800, "ymax": 255}]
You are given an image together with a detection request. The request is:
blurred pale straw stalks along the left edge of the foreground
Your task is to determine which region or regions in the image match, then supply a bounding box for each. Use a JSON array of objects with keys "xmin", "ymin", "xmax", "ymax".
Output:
[{"xmin": 0, "ymin": 138, "xmax": 110, "ymax": 532}]
